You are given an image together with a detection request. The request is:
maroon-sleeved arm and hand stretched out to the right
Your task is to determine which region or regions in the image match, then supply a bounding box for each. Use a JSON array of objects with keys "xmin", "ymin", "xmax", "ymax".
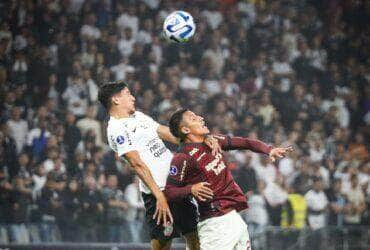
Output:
[{"xmin": 215, "ymin": 136, "xmax": 293, "ymax": 161}]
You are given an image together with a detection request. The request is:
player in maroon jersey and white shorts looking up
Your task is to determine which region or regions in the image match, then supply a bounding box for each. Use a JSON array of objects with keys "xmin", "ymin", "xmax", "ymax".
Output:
[{"xmin": 165, "ymin": 109, "xmax": 292, "ymax": 250}]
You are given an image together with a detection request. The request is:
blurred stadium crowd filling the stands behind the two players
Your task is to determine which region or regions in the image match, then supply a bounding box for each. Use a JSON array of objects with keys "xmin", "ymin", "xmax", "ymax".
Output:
[{"xmin": 0, "ymin": 0, "xmax": 370, "ymax": 243}]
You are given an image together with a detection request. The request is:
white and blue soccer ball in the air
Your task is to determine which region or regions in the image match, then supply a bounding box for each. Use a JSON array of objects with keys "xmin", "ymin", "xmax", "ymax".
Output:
[{"xmin": 163, "ymin": 10, "xmax": 195, "ymax": 43}]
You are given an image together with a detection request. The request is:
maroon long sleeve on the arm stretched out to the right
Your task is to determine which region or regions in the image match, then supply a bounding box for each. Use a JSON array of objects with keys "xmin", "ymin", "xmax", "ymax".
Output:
[{"xmin": 215, "ymin": 135, "xmax": 272, "ymax": 154}]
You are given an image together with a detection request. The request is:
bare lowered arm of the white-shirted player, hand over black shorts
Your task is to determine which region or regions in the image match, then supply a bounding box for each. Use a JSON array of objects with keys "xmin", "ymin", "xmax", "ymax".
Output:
[{"xmin": 124, "ymin": 151, "xmax": 173, "ymax": 225}]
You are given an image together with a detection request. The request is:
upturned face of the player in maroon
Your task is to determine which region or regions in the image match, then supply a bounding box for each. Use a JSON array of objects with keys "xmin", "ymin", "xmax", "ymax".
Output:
[{"xmin": 182, "ymin": 111, "xmax": 209, "ymax": 135}]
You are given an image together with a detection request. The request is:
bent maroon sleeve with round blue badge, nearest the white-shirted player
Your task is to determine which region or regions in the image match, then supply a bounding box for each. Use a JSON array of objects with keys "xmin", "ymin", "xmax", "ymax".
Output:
[{"xmin": 164, "ymin": 154, "xmax": 193, "ymax": 201}]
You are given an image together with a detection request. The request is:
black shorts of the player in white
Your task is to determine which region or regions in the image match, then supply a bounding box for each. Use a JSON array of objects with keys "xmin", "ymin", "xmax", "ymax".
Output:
[{"xmin": 142, "ymin": 193, "xmax": 199, "ymax": 240}]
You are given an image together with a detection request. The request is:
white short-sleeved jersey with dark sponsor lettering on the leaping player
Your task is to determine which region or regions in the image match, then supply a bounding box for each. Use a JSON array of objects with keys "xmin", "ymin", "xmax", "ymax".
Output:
[{"xmin": 107, "ymin": 111, "xmax": 173, "ymax": 193}]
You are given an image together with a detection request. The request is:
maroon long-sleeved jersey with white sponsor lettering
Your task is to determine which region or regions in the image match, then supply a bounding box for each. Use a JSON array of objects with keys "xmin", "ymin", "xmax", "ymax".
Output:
[{"xmin": 165, "ymin": 136, "xmax": 271, "ymax": 220}]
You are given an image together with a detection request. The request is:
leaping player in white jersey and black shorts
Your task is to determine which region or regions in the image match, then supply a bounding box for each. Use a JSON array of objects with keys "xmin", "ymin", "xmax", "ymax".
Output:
[{"xmin": 99, "ymin": 82, "xmax": 219, "ymax": 249}]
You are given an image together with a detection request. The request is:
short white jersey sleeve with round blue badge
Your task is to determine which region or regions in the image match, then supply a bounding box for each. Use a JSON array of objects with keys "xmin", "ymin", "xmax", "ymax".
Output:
[{"xmin": 109, "ymin": 126, "xmax": 137, "ymax": 157}]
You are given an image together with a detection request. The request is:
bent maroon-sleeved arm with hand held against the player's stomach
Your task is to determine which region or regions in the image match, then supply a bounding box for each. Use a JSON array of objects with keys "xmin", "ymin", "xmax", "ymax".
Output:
[{"xmin": 164, "ymin": 154, "xmax": 213, "ymax": 201}]
